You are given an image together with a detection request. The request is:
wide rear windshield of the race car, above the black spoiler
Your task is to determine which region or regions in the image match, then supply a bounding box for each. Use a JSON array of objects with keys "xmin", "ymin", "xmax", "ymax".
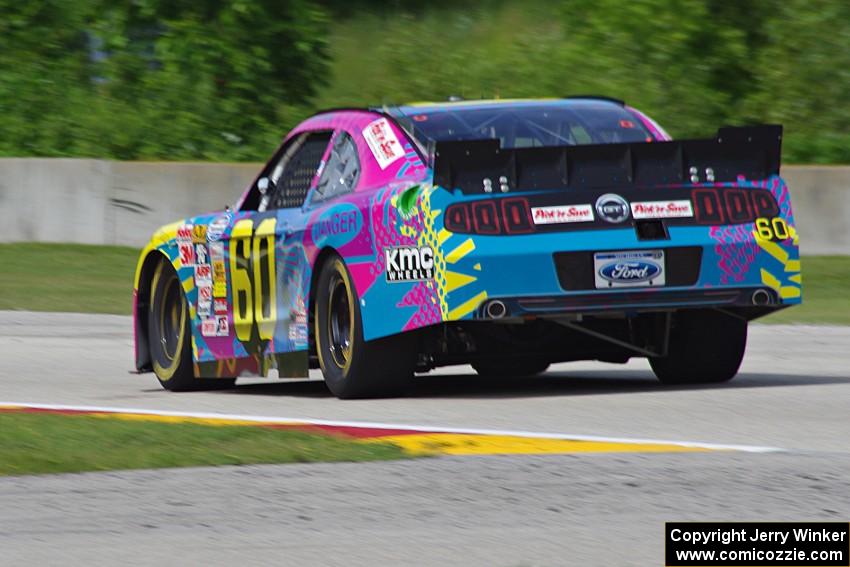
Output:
[{"xmin": 399, "ymin": 102, "xmax": 653, "ymax": 149}]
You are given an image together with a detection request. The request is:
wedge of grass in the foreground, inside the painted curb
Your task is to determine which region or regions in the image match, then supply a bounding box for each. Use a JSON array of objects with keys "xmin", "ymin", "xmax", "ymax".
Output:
[{"xmin": 0, "ymin": 412, "xmax": 411, "ymax": 475}]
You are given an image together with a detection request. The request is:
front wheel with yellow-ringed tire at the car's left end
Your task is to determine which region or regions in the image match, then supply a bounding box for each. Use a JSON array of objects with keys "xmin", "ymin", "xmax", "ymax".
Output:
[{"xmin": 147, "ymin": 261, "xmax": 236, "ymax": 392}]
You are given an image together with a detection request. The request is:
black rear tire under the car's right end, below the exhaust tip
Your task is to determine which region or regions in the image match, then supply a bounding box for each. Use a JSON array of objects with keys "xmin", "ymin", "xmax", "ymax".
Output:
[{"xmin": 649, "ymin": 311, "xmax": 747, "ymax": 384}]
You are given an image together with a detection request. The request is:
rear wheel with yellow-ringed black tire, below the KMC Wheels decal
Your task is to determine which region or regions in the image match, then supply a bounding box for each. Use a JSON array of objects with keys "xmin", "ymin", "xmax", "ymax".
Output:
[{"xmin": 313, "ymin": 256, "xmax": 416, "ymax": 399}]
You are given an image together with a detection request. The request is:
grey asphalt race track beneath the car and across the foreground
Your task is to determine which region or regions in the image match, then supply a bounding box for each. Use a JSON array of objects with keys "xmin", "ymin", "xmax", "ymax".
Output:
[{"xmin": 0, "ymin": 312, "xmax": 850, "ymax": 566}]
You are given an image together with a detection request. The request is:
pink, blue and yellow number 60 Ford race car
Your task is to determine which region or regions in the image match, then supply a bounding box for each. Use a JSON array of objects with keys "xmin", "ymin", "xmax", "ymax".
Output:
[{"xmin": 134, "ymin": 97, "xmax": 801, "ymax": 398}]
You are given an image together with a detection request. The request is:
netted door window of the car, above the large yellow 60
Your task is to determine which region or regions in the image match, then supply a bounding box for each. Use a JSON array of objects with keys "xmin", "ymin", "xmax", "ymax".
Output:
[{"xmin": 258, "ymin": 132, "xmax": 332, "ymax": 211}]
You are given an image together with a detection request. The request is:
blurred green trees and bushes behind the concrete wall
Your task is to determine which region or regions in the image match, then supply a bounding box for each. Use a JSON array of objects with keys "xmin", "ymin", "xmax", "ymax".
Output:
[{"xmin": 0, "ymin": 0, "xmax": 850, "ymax": 163}]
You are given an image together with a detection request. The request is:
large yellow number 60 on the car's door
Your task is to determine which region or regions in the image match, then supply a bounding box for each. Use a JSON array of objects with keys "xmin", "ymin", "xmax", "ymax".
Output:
[{"xmin": 230, "ymin": 218, "xmax": 277, "ymax": 342}]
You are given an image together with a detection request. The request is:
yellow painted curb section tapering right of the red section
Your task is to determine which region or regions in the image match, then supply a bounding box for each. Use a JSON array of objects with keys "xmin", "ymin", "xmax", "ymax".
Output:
[{"xmin": 360, "ymin": 433, "xmax": 708, "ymax": 455}]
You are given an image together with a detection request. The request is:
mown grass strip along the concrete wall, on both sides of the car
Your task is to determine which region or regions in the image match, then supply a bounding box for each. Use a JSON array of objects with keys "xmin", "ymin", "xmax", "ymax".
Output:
[{"xmin": 0, "ymin": 243, "xmax": 850, "ymax": 325}]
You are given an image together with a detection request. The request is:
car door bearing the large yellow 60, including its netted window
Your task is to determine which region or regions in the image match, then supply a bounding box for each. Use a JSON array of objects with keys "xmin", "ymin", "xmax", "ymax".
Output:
[{"xmin": 229, "ymin": 131, "xmax": 332, "ymax": 377}]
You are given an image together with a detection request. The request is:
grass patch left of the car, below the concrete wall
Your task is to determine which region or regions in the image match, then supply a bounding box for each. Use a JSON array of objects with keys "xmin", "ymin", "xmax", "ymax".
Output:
[{"xmin": 0, "ymin": 243, "xmax": 139, "ymax": 315}]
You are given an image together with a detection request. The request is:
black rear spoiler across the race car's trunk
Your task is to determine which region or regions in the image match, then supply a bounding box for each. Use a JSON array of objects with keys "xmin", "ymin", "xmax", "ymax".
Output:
[{"xmin": 432, "ymin": 125, "xmax": 782, "ymax": 194}]
